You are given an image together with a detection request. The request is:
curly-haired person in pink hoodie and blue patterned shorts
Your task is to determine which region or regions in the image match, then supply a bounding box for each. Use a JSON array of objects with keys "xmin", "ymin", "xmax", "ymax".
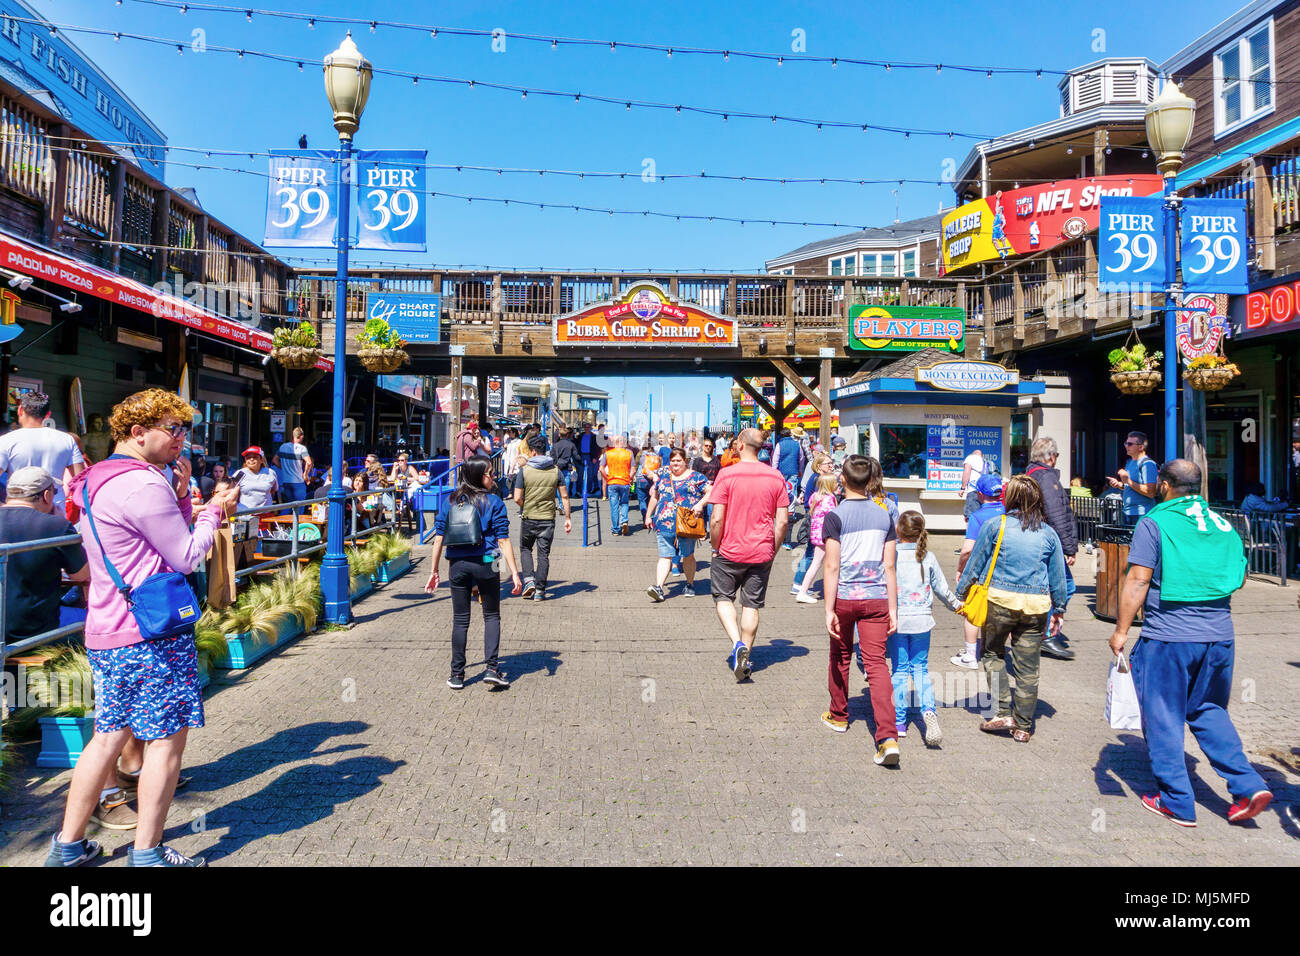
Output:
[{"xmin": 46, "ymin": 389, "xmax": 239, "ymax": 866}]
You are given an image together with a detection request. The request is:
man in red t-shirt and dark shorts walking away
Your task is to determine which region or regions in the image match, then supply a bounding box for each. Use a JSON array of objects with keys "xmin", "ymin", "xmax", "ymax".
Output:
[{"xmin": 709, "ymin": 428, "xmax": 790, "ymax": 683}]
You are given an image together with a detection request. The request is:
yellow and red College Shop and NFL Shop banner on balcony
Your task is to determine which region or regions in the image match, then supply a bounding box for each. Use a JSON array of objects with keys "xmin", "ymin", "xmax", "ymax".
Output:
[{"xmin": 943, "ymin": 174, "xmax": 1161, "ymax": 274}]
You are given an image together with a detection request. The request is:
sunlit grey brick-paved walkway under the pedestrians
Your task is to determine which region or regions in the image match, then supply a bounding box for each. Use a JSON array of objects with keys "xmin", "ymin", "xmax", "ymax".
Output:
[{"xmin": 0, "ymin": 512, "xmax": 1300, "ymax": 866}]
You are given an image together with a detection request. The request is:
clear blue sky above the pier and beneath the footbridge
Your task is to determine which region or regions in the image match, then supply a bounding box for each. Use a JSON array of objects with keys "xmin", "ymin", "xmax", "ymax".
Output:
[{"xmin": 31, "ymin": 0, "xmax": 1238, "ymax": 418}]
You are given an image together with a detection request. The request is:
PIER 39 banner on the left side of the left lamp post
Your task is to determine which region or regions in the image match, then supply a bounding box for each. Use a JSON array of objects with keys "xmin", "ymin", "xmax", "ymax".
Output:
[{"xmin": 263, "ymin": 150, "xmax": 338, "ymax": 248}]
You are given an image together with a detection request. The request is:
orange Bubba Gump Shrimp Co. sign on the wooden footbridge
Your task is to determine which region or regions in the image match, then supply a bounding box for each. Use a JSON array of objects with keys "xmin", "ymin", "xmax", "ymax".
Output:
[{"xmin": 554, "ymin": 282, "xmax": 736, "ymax": 349}]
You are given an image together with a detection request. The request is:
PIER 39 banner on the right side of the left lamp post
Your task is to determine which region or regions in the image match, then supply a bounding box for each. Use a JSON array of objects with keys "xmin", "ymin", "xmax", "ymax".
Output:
[{"xmin": 356, "ymin": 150, "xmax": 428, "ymax": 252}]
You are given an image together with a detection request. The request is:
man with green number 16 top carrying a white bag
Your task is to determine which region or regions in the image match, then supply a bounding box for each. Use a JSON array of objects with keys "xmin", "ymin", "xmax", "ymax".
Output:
[{"xmin": 1110, "ymin": 458, "xmax": 1273, "ymax": 827}]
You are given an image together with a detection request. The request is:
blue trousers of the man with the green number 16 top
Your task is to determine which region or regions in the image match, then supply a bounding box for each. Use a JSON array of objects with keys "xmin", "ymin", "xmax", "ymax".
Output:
[{"xmin": 1130, "ymin": 639, "xmax": 1268, "ymax": 819}]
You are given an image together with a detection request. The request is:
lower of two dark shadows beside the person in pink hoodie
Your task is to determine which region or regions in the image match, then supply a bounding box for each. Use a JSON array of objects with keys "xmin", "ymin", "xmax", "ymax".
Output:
[{"xmin": 188, "ymin": 757, "xmax": 406, "ymax": 861}]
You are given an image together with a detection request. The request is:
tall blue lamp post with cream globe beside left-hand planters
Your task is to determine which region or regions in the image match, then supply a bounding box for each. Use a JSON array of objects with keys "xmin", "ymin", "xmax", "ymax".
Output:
[{"xmin": 321, "ymin": 31, "xmax": 371, "ymax": 624}]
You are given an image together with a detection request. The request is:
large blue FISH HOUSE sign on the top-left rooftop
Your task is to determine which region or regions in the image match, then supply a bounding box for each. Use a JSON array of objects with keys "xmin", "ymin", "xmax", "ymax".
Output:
[{"xmin": 0, "ymin": 0, "xmax": 167, "ymax": 179}]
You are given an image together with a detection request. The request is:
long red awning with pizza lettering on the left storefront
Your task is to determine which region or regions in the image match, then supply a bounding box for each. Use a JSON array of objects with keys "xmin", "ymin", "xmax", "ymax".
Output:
[{"xmin": 0, "ymin": 232, "xmax": 334, "ymax": 372}]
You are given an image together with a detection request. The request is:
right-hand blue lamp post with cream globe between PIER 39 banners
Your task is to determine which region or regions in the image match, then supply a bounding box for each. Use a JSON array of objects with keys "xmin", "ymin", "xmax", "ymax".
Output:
[{"xmin": 1147, "ymin": 79, "xmax": 1205, "ymax": 462}]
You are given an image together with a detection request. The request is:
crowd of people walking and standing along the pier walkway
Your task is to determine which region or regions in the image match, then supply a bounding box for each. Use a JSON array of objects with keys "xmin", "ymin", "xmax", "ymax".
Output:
[{"xmin": 0, "ymin": 389, "xmax": 1273, "ymax": 866}]
